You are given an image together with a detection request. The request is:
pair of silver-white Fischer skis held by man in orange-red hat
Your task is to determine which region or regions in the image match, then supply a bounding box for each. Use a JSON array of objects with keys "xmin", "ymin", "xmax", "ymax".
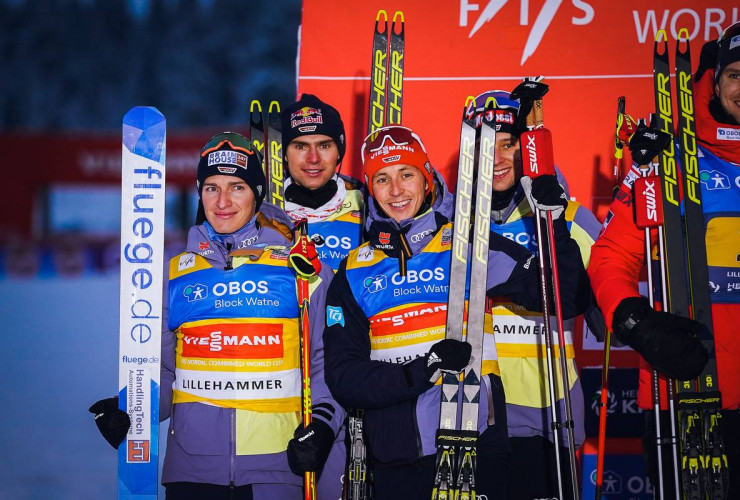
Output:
[{"xmin": 432, "ymin": 97, "xmax": 496, "ymax": 500}]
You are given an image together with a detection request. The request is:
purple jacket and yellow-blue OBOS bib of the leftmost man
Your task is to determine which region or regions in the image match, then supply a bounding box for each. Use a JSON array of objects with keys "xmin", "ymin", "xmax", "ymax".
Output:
[{"xmin": 160, "ymin": 203, "xmax": 345, "ymax": 499}]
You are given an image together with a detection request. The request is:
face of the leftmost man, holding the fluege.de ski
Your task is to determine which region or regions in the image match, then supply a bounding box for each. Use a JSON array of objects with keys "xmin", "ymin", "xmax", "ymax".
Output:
[{"xmin": 200, "ymin": 175, "xmax": 256, "ymax": 234}]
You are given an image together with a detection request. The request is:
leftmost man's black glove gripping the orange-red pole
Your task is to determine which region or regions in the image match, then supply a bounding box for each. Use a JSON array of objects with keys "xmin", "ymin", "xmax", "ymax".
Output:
[{"xmin": 288, "ymin": 419, "xmax": 334, "ymax": 476}]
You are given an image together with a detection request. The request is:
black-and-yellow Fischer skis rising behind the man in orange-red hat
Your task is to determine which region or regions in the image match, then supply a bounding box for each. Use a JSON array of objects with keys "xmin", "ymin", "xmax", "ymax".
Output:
[{"xmin": 342, "ymin": 9, "xmax": 405, "ymax": 500}]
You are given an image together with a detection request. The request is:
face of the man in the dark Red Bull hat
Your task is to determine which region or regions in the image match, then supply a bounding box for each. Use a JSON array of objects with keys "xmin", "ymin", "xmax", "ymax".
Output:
[{"xmin": 285, "ymin": 134, "xmax": 339, "ymax": 189}]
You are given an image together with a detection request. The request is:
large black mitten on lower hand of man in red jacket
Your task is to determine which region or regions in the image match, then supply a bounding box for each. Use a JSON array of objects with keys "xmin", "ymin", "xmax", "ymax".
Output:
[{"xmin": 612, "ymin": 297, "xmax": 709, "ymax": 380}]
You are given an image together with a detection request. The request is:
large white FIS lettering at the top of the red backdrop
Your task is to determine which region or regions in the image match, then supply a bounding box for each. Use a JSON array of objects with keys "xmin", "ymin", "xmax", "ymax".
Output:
[{"xmin": 459, "ymin": 0, "xmax": 594, "ymax": 65}]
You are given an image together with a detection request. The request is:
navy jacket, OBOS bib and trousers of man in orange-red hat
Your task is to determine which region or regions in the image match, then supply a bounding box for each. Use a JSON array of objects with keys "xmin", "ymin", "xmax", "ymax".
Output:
[{"xmin": 324, "ymin": 171, "xmax": 590, "ymax": 498}]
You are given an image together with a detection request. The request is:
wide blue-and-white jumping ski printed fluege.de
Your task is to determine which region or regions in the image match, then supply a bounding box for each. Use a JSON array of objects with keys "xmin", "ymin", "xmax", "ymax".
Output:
[{"xmin": 118, "ymin": 106, "xmax": 166, "ymax": 500}]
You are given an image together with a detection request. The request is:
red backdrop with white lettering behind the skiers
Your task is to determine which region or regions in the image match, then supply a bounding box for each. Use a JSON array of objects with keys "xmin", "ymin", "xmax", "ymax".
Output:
[{"xmin": 298, "ymin": 0, "xmax": 740, "ymax": 222}]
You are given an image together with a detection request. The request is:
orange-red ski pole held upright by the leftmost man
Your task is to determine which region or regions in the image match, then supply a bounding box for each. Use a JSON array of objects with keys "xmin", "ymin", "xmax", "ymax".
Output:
[{"xmin": 288, "ymin": 219, "xmax": 321, "ymax": 500}]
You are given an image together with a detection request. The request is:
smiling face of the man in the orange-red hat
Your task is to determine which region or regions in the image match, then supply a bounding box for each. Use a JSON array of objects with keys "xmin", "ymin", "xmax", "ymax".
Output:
[{"xmin": 370, "ymin": 163, "xmax": 427, "ymax": 222}]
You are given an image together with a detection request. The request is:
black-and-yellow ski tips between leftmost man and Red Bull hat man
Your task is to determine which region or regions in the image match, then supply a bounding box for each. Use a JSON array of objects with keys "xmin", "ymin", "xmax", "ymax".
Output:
[{"xmin": 249, "ymin": 99, "xmax": 285, "ymax": 208}]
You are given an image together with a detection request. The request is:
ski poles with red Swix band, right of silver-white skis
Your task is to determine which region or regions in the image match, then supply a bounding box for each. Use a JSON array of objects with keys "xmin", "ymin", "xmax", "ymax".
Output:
[{"xmin": 513, "ymin": 78, "xmax": 580, "ymax": 500}]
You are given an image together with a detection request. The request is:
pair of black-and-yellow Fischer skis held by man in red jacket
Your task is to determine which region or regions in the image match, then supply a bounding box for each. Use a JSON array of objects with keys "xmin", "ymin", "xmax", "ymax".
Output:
[{"xmin": 653, "ymin": 29, "xmax": 728, "ymax": 500}]
